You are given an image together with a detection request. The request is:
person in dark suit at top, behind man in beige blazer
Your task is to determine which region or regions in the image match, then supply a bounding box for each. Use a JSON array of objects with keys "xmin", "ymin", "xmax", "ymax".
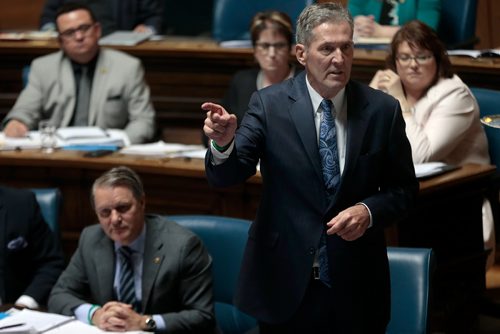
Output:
[{"xmin": 40, "ymin": 0, "xmax": 163, "ymax": 35}]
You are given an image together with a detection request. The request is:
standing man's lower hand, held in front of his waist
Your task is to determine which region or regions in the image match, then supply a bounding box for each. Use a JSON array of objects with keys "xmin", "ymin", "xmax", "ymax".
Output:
[{"xmin": 326, "ymin": 204, "xmax": 370, "ymax": 241}]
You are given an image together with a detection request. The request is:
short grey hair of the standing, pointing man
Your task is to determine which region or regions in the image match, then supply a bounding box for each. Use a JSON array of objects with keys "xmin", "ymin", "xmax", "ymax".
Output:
[{"xmin": 295, "ymin": 2, "xmax": 354, "ymax": 46}]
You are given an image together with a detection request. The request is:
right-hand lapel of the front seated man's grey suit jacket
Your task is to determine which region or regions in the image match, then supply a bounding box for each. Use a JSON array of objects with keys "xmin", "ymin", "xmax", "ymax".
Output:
[{"xmin": 142, "ymin": 218, "xmax": 164, "ymax": 312}]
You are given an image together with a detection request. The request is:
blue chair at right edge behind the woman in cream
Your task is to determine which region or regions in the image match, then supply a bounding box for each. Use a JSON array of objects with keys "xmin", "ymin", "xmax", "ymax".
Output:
[{"xmin": 471, "ymin": 87, "xmax": 500, "ymax": 169}]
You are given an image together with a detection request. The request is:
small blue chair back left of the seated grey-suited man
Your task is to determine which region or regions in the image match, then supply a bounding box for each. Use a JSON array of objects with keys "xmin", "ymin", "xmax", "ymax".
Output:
[{"xmin": 31, "ymin": 188, "xmax": 62, "ymax": 241}]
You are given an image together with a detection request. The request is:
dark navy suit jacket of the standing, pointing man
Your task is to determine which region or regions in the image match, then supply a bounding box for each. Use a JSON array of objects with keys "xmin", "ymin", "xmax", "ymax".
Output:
[{"xmin": 206, "ymin": 72, "xmax": 418, "ymax": 333}]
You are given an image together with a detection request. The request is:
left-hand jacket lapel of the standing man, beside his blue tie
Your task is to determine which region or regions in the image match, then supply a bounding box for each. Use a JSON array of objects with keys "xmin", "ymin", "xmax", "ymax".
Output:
[{"xmin": 289, "ymin": 71, "xmax": 323, "ymax": 180}]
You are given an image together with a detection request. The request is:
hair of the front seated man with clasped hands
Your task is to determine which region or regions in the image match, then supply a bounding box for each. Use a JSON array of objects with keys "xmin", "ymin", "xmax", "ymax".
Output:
[{"xmin": 90, "ymin": 166, "xmax": 145, "ymax": 209}]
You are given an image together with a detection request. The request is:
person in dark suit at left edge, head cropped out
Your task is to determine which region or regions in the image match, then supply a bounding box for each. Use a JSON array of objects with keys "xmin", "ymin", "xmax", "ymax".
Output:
[{"xmin": 0, "ymin": 187, "xmax": 64, "ymax": 309}]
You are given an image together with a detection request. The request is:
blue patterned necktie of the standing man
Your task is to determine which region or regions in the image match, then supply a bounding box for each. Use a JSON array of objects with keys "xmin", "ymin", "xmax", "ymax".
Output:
[{"xmin": 318, "ymin": 100, "xmax": 340, "ymax": 287}]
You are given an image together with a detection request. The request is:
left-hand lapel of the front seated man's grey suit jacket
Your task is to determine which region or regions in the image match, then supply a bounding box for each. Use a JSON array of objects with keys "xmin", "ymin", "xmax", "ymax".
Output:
[{"xmin": 92, "ymin": 236, "xmax": 115, "ymax": 300}]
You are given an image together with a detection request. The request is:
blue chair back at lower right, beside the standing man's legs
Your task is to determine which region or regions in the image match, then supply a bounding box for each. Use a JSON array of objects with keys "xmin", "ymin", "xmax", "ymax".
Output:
[{"xmin": 387, "ymin": 247, "xmax": 434, "ymax": 334}]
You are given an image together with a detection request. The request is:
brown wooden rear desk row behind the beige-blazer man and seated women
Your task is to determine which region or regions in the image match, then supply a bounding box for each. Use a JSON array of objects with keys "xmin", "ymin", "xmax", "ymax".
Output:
[{"xmin": 0, "ymin": 37, "xmax": 500, "ymax": 142}]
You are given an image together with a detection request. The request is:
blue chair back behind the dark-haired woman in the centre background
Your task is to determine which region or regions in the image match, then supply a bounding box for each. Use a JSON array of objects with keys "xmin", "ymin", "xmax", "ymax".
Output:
[{"xmin": 212, "ymin": 0, "xmax": 315, "ymax": 42}]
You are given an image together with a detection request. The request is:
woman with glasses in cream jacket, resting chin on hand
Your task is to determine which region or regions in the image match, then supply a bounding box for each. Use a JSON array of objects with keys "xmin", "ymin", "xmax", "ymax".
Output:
[{"xmin": 370, "ymin": 20, "xmax": 495, "ymax": 266}]
